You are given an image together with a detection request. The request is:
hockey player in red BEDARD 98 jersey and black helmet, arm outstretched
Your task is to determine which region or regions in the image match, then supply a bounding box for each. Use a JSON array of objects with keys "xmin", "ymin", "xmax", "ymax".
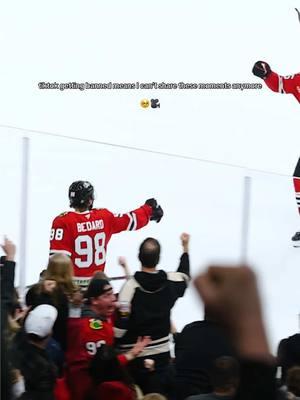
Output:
[{"xmin": 50, "ymin": 181, "xmax": 163, "ymax": 286}]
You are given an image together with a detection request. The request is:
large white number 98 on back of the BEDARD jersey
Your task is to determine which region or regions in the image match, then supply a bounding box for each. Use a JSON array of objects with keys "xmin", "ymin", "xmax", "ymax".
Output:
[{"xmin": 75, "ymin": 232, "xmax": 106, "ymax": 268}]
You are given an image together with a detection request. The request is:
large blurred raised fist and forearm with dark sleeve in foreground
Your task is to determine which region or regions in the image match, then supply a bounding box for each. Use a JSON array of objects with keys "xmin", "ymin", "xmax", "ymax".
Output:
[{"xmin": 195, "ymin": 265, "xmax": 277, "ymax": 400}]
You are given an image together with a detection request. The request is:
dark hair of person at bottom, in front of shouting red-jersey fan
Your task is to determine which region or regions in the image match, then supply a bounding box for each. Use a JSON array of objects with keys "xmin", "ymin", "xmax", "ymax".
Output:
[{"xmin": 89, "ymin": 344, "xmax": 133, "ymax": 385}]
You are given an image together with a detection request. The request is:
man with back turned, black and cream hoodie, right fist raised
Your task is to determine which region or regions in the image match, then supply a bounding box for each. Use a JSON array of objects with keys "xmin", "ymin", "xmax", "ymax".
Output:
[{"xmin": 115, "ymin": 233, "xmax": 190, "ymax": 394}]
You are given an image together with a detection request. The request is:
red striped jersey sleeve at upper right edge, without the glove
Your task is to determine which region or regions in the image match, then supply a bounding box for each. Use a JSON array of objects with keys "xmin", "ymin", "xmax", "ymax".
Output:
[{"xmin": 265, "ymin": 72, "xmax": 300, "ymax": 103}]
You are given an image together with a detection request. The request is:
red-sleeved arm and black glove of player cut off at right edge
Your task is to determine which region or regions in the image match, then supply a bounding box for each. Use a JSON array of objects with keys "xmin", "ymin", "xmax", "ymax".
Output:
[{"xmin": 252, "ymin": 61, "xmax": 300, "ymax": 103}]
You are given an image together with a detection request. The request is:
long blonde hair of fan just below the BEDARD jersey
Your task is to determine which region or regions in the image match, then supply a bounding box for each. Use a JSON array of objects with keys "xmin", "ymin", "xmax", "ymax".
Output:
[{"xmin": 43, "ymin": 253, "xmax": 78, "ymax": 296}]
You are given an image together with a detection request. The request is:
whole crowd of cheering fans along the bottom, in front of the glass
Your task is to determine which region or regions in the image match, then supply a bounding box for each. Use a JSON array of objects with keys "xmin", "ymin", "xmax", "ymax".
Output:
[{"xmin": 0, "ymin": 200, "xmax": 300, "ymax": 400}]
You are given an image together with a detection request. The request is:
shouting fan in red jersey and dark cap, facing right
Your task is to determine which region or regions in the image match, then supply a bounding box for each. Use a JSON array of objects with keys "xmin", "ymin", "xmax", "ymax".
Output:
[{"xmin": 65, "ymin": 278, "xmax": 151, "ymax": 400}]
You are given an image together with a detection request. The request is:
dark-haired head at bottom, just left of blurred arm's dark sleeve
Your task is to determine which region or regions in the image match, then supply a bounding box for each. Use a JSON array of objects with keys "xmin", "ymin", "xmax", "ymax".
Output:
[{"xmin": 211, "ymin": 356, "xmax": 239, "ymax": 389}]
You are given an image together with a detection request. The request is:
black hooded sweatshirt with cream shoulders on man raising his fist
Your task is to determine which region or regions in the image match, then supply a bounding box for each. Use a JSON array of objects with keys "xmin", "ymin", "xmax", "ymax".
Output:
[{"xmin": 115, "ymin": 253, "xmax": 190, "ymax": 355}]
